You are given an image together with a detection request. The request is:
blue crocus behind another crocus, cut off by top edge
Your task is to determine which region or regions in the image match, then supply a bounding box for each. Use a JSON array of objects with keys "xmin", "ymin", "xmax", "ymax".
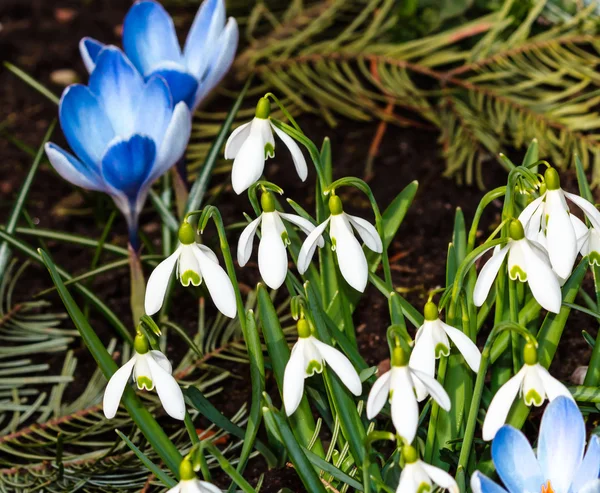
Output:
[{"xmin": 79, "ymin": 0, "xmax": 238, "ymax": 110}]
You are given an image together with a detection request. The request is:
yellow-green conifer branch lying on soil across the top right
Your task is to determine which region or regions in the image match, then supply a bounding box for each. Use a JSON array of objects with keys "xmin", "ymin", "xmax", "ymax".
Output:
[{"xmin": 191, "ymin": 0, "xmax": 600, "ymax": 186}]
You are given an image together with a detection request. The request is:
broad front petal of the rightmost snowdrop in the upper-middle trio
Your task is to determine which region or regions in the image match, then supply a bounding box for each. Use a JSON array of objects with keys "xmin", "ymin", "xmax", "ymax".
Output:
[{"xmin": 330, "ymin": 214, "xmax": 369, "ymax": 293}]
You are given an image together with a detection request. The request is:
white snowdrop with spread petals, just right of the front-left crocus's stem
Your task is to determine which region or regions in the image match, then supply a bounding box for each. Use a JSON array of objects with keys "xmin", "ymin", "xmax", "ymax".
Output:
[{"xmin": 144, "ymin": 221, "xmax": 237, "ymax": 318}]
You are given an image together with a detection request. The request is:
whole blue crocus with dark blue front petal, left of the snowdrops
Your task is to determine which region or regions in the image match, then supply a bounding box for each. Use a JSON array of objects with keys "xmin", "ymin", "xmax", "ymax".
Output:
[{"xmin": 46, "ymin": 47, "xmax": 191, "ymax": 247}]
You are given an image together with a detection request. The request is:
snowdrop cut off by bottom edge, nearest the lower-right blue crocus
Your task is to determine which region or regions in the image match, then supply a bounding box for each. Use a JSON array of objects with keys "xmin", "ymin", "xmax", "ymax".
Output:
[{"xmin": 396, "ymin": 445, "xmax": 459, "ymax": 493}]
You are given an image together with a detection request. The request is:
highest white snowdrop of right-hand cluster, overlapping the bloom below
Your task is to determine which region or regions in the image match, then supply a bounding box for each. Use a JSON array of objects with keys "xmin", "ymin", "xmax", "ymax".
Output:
[{"xmin": 519, "ymin": 168, "xmax": 600, "ymax": 279}]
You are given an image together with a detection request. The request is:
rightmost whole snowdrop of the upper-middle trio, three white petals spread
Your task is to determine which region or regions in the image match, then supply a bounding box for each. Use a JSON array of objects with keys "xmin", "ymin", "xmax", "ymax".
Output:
[{"xmin": 298, "ymin": 195, "xmax": 383, "ymax": 292}]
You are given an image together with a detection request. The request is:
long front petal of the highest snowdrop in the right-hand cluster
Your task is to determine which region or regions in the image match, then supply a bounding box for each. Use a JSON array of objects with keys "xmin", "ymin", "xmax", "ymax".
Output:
[{"xmin": 546, "ymin": 190, "xmax": 577, "ymax": 278}]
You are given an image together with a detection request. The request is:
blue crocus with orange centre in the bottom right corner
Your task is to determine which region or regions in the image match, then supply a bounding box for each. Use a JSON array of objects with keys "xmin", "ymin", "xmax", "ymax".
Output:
[{"xmin": 471, "ymin": 396, "xmax": 600, "ymax": 493}]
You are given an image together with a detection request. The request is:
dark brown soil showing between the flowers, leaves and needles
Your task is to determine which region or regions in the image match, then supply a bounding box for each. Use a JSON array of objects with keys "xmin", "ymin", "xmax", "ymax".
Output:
[{"xmin": 0, "ymin": 0, "xmax": 596, "ymax": 492}]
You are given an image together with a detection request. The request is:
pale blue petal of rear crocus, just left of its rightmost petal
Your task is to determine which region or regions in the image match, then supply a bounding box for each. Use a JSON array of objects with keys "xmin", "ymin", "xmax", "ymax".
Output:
[{"xmin": 183, "ymin": 0, "xmax": 225, "ymax": 79}]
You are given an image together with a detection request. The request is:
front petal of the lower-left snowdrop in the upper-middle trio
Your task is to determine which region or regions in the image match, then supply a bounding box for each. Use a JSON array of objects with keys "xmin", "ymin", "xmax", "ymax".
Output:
[{"xmin": 258, "ymin": 212, "xmax": 288, "ymax": 289}]
